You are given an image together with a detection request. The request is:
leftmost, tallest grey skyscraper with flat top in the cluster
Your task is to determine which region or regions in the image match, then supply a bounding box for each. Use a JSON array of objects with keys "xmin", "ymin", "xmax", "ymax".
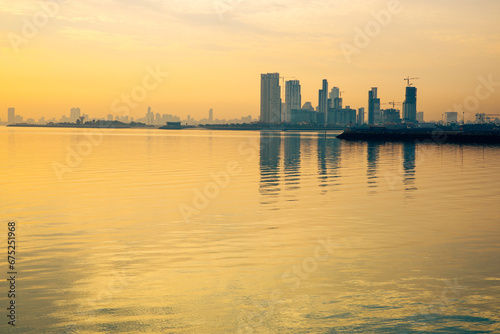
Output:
[{"xmin": 260, "ymin": 73, "xmax": 281, "ymax": 123}]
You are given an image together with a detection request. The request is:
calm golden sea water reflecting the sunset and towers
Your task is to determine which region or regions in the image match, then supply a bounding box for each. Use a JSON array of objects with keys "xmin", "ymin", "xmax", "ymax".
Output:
[{"xmin": 0, "ymin": 127, "xmax": 500, "ymax": 333}]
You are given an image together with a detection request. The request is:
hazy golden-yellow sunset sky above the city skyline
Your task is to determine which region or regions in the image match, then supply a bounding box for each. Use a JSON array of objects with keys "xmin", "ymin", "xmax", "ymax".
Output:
[{"xmin": 0, "ymin": 0, "xmax": 500, "ymax": 121}]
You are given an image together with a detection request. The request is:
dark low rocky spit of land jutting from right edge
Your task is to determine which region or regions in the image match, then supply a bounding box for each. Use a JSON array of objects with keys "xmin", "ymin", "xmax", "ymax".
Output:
[{"xmin": 337, "ymin": 126, "xmax": 500, "ymax": 144}]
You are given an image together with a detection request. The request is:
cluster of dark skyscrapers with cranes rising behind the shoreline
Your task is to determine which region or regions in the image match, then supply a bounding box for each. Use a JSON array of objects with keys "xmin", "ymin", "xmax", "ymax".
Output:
[{"xmin": 260, "ymin": 73, "xmax": 423, "ymax": 125}]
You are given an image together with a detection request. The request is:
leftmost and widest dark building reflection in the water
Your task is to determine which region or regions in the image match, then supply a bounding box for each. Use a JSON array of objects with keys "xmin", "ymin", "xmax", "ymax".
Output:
[{"xmin": 259, "ymin": 132, "xmax": 281, "ymax": 201}]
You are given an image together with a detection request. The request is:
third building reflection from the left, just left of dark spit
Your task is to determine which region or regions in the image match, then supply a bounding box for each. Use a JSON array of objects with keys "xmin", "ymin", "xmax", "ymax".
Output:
[{"xmin": 318, "ymin": 137, "xmax": 342, "ymax": 187}]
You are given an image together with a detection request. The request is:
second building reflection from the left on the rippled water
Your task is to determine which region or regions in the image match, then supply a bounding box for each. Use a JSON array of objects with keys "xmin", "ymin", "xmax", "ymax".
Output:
[{"xmin": 283, "ymin": 134, "xmax": 300, "ymax": 190}]
